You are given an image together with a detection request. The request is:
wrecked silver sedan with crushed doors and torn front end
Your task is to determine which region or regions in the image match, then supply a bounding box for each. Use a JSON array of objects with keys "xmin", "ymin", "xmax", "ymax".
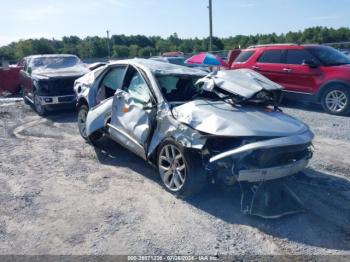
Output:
[{"xmin": 74, "ymin": 59, "xmax": 313, "ymax": 196}]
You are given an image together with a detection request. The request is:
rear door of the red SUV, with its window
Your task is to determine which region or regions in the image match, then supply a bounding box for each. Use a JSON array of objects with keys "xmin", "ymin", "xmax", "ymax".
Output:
[{"xmin": 252, "ymin": 49, "xmax": 286, "ymax": 87}]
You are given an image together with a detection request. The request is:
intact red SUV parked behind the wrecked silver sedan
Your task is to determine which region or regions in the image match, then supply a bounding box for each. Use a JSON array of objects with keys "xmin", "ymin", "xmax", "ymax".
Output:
[{"xmin": 231, "ymin": 44, "xmax": 350, "ymax": 115}]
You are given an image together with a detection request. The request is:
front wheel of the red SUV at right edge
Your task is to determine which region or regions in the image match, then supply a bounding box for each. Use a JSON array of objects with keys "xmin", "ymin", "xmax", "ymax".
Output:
[{"xmin": 321, "ymin": 85, "xmax": 350, "ymax": 115}]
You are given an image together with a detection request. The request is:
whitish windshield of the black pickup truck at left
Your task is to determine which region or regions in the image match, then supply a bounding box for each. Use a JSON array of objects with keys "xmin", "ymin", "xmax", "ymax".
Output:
[{"xmin": 30, "ymin": 56, "xmax": 82, "ymax": 70}]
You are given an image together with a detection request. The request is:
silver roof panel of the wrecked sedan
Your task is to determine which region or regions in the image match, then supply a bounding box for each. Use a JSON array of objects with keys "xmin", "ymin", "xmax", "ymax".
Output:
[{"xmin": 111, "ymin": 58, "xmax": 207, "ymax": 76}]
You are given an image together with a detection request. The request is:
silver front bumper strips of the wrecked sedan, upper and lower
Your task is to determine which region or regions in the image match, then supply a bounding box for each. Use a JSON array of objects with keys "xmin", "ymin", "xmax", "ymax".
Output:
[{"xmin": 209, "ymin": 130, "xmax": 314, "ymax": 182}]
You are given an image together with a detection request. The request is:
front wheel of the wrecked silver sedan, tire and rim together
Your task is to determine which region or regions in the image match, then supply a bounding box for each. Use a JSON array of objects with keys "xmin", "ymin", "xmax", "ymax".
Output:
[{"xmin": 157, "ymin": 139, "xmax": 207, "ymax": 198}]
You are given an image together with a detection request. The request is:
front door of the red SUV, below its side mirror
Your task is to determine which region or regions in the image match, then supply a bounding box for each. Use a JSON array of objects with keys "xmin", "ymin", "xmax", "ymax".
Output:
[{"xmin": 283, "ymin": 49, "xmax": 322, "ymax": 93}]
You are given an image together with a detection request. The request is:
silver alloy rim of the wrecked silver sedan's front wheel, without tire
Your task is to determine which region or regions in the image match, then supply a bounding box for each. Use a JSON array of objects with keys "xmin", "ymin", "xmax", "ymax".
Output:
[{"xmin": 158, "ymin": 145, "xmax": 187, "ymax": 192}]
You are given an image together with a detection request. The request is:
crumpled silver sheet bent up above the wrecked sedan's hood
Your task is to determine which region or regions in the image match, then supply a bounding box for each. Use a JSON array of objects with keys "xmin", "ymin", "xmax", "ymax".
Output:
[{"xmin": 197, "ymin": 69, "xmax": 283, "ymax": 99}]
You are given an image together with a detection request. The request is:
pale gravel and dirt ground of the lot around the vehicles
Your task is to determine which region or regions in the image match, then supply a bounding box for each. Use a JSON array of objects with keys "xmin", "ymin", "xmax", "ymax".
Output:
[{"xmin": 0, "ymin": 99, "xmax": 350, "ymax": 256}]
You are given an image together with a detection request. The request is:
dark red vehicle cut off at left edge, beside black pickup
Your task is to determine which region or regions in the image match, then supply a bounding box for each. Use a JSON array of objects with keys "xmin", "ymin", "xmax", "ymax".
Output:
[{"xmin": 0, "ymin": 63, "xmax": 22, "ymax": 95}]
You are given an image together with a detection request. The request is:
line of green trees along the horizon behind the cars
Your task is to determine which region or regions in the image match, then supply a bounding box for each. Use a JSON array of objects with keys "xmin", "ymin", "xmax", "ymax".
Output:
[{"xmin": 0, "ymin": 26, "xmax": 350, "ymax": 60}]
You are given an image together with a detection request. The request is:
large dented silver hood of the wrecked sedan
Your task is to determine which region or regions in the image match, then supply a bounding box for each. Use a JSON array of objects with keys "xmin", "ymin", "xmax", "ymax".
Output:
[{"xmin": 172, "ymin": 100, "xmax": 309, "ymax": 137}]
